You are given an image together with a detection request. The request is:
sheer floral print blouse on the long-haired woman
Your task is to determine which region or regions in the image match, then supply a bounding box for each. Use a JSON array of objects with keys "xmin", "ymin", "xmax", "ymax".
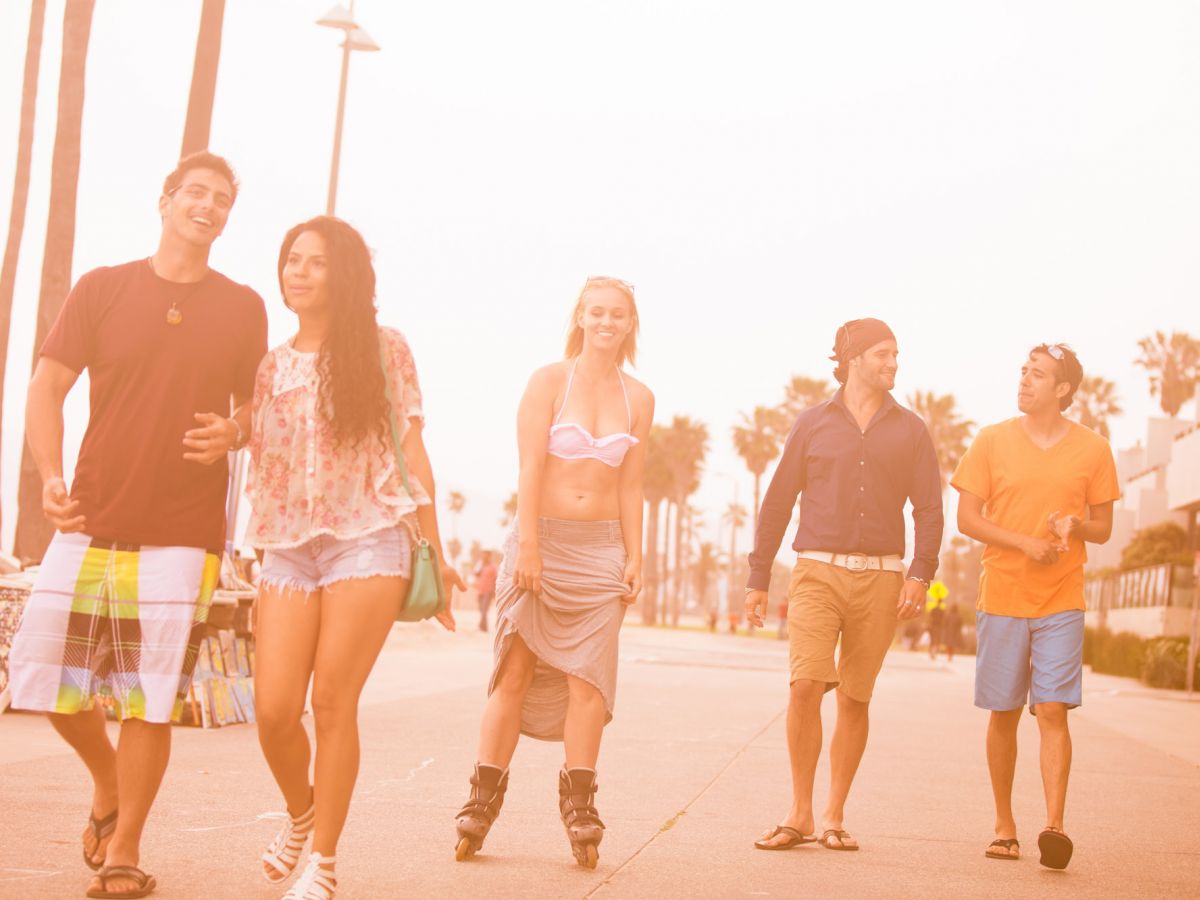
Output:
[{"xmin": 246, "ymin": 328, "xmax": 430, "ymax": 550}]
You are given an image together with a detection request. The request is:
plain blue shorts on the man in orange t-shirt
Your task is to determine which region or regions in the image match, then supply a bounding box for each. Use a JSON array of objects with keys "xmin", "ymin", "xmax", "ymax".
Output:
[{"xmin": 976, "ymin": 610, "xmax": 1084, "ymax": 713}]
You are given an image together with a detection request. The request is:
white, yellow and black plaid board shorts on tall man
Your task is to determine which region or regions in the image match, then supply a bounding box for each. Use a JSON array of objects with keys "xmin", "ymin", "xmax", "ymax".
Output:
[{"xmin": 8, "ymin": 533, "xmax": 221, "ymax": 722}]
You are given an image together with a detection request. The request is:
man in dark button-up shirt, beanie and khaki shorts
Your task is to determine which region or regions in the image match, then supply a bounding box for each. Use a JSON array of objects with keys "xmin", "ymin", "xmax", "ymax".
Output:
[{"xmin": 745, "ymin": 319, "xmax": 942, "ymax": 851}]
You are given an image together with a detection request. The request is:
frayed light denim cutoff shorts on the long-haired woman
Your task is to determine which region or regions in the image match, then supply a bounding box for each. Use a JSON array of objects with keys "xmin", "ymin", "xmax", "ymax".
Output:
[{"xmin": 259, "ymin": 524, "xmax": 413, "ymax": 593}]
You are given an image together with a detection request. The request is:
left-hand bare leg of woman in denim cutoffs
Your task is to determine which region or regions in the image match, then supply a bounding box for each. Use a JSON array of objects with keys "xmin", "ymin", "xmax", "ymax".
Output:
[{"xmin": 254, "ymin": 584, "xmax": 320, "ymax": 877}]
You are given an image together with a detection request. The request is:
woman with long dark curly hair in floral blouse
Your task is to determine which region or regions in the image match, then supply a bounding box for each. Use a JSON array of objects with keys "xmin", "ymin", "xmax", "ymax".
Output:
[{"xmin": 247, "ymin": 216, "xmax": 464, "ymax": 900}]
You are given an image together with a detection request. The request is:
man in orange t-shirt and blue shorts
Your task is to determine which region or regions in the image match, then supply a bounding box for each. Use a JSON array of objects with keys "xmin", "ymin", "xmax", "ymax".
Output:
[{"xmin": 950, "ymin": 344, "xmax": 1121, "ymax": 869}]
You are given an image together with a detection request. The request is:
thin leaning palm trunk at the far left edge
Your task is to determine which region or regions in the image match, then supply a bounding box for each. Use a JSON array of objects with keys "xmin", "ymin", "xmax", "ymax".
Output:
[{"xmin": 0, "ymin": 0, "xmax": 46, "ymax": 542}]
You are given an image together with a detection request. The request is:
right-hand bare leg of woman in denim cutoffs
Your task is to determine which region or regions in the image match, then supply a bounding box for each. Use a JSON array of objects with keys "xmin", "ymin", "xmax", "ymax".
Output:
[{"xmin": 312, "ymin": 575, "xmax": 408, "ymax": 857}]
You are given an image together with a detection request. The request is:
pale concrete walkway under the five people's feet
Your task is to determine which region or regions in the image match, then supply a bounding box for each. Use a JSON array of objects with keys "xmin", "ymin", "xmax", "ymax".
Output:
[{"xmin": 0, "ymin": 624, "xmax": 1200, "ymax": 898}]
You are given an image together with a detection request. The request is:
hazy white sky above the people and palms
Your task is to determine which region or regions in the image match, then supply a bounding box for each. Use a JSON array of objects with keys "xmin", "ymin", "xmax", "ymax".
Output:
[{"xmin": 0, "ymin": 0, "xmax": 1200, "ymax": 548}]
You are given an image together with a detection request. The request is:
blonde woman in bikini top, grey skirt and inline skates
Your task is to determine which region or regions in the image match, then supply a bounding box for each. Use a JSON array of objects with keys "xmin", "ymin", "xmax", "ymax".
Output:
[{"xmin": 455, "ymin": 277, "xmax": 654, "ymax": 869}]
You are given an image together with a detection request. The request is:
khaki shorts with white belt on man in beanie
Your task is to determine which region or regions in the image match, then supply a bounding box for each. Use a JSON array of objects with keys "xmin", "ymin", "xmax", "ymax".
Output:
[{"xmin": 787, "ymin": 559, "xmax": 904, "ymax": 703}]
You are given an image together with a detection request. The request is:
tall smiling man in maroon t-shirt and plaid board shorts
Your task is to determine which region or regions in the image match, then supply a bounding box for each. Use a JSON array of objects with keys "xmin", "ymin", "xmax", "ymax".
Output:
[{"xmin": 10, "ymin": 152, "xmax": 266, "ymax": 898}]
